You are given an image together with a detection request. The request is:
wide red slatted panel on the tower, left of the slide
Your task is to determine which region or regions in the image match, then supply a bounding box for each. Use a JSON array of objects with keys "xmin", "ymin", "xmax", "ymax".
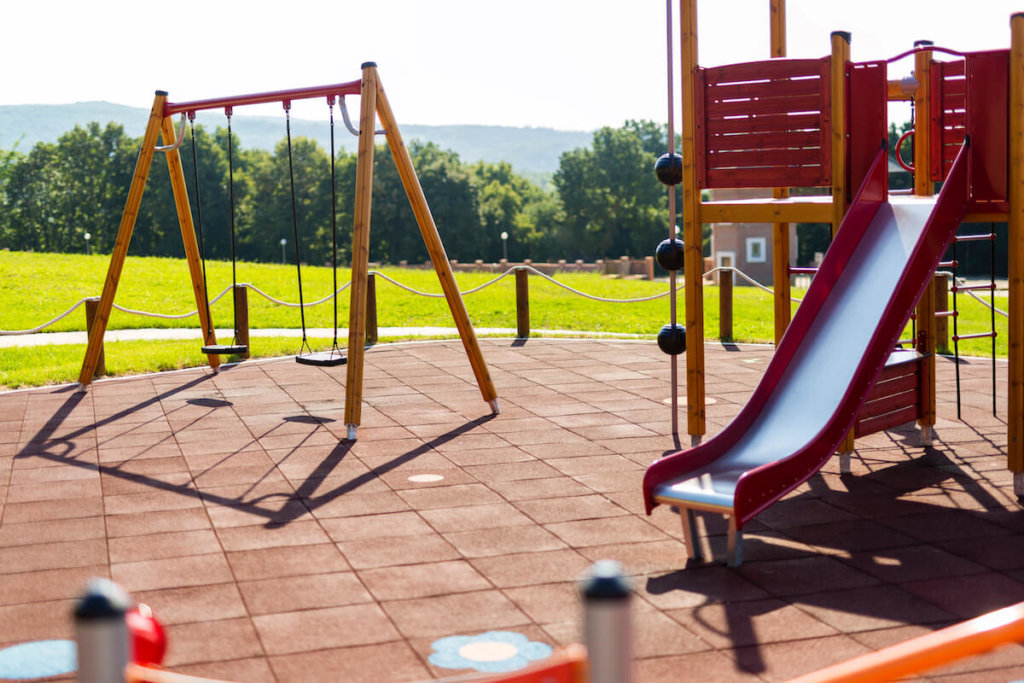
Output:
[{"xmin": 694, "ymin": 57, "xmax": 831, "ymax": 187}]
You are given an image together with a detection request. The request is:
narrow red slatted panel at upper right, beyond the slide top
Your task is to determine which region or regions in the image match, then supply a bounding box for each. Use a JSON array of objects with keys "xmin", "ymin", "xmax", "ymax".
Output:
[{"xmin": 931, "ymin": 59, "xmax": 967, "ymax": 180}]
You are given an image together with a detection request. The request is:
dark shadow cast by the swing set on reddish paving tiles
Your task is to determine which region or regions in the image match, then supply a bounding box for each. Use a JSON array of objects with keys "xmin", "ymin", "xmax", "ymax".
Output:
[{"xmin": 14, "ymin": 376, "xmax": 496, "ymax": 528}]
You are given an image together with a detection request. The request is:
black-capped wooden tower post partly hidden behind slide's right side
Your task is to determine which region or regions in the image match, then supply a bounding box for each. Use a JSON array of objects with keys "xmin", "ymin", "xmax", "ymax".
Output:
[{"xmin": 913, "ymin": 40, "xmax": 936, "ymax": 445}]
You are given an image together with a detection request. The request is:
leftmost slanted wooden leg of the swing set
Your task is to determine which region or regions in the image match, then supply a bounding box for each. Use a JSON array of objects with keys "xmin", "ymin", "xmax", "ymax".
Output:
[{"xmin": 78, "ymin": 90, "xmax": 173, "ymax": 391}]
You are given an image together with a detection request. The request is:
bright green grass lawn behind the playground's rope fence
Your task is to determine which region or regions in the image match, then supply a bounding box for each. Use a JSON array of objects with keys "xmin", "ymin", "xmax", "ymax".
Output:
[{"xmin": 0, "ymin": 252, "xmax": 1007, "ymax": 388}]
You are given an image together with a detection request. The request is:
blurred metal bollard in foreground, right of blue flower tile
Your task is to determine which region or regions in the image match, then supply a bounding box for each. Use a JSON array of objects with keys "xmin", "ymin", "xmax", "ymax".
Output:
[{"xmin": 581, "ymin": 560, "xmax": 633, "ymax": 683}]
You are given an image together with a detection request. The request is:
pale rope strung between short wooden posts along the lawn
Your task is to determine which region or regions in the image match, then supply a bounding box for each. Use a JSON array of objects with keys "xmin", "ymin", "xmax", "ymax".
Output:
[{"xmin": 0, "ymin": 265, "xmax": 1010, "ymax": 336}]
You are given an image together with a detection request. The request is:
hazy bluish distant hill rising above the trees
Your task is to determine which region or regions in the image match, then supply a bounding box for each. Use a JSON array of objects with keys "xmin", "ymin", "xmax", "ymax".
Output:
[{"xmin": 0, "ymin": 101, "xmax": 592, "ymax": 177}]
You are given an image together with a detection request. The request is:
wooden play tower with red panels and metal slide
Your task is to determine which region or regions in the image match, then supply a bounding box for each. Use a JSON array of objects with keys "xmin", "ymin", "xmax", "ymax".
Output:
[{"xmin": 643, "ymin": 0, "xmax": 1024, "ymax": 565}]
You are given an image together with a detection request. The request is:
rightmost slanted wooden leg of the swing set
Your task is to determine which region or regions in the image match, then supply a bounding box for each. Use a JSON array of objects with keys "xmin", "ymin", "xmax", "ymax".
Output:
[{"xmin": 368, "ymin": 62, "xmax": 501, "ymax": 415}]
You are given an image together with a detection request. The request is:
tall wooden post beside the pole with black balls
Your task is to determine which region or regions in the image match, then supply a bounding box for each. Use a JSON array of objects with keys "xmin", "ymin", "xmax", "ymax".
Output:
[{"xmin": 679, "ymin": 0, "xmax": 707, "ymax": 445}]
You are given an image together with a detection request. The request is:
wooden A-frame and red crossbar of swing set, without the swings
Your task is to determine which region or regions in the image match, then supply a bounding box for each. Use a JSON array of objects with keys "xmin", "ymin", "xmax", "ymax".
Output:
[{"xmin": 78, "ymin": 61, "xmax": 500, "ymax": 439}]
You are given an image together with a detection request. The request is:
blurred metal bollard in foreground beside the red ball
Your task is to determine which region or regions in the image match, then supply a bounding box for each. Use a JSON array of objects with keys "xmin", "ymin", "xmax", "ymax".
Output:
[{"xmin": 75, "ymin": 579, "xmax": 131, "ymax": 683}]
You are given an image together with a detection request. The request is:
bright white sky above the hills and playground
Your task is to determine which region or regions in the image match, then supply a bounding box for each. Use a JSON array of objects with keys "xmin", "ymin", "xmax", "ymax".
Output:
[{"xmin": 0, "ymin": 0, "xmax": 1024, "ymax": 130}]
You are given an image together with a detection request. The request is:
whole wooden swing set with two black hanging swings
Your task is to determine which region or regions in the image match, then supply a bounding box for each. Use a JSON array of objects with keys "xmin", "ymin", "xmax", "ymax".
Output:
[{"xmin": 78, "ymin": 62, "xmax": 500, "ymax": 439}]
